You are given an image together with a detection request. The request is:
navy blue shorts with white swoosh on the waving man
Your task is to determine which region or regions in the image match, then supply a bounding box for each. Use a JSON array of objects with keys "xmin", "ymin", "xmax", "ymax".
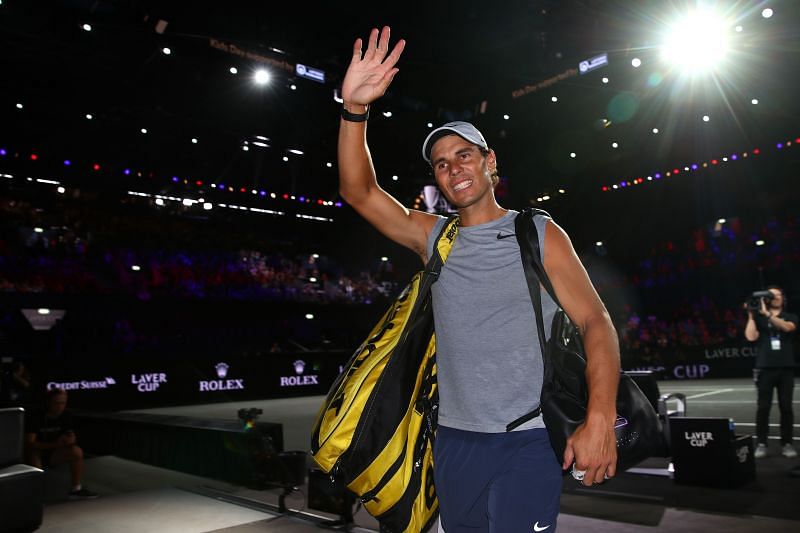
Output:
[{"xmin": 434, "ymin": 426, "xmax": 562, "ymax": 533}]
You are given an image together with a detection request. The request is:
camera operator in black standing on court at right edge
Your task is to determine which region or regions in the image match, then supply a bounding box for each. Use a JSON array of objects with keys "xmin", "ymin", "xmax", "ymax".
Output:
[{"xmin": 744, "ymin": 285, "xmax": 797, "ymax": 458}]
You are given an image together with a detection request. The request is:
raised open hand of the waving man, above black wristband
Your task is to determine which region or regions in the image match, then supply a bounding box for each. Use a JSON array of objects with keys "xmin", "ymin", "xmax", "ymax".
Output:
[{"xmin": 342, "ymin": 26, "xmax": 406, "ymax": 106}]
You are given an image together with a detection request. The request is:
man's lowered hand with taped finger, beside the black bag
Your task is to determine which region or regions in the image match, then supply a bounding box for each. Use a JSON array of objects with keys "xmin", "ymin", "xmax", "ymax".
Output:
[{"xmin": 561, "ymin": 417, "xmax": 617, "ymax": 487}]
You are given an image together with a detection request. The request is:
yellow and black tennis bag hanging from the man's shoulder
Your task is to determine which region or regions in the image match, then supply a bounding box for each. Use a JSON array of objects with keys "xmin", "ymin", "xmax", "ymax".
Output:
[{"xmin": 311, "ymin": 217, "xmax": 458, "ymax": 533}]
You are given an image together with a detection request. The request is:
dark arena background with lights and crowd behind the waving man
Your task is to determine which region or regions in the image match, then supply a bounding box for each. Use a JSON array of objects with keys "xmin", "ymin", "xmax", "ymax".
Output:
[{"xmin": 0, "ymin": 0, "xmax": 800, "ymax": 533}]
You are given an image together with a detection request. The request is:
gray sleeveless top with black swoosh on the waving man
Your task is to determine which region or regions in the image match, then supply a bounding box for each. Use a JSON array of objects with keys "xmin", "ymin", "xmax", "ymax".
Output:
[{"xmin": 428, "ymin": 210, "xmax": 556, "ymax": 433}]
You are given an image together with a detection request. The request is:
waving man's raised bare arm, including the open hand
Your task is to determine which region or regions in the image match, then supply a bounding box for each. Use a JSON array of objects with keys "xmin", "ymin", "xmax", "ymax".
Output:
[{"xmin": 338, "ymin": 27, "xmax": 436, "ymax": 261}]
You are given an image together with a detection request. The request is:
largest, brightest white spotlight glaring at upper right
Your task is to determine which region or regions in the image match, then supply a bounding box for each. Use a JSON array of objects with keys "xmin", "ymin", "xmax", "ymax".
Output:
[{"xmin": 662, "ymin": 11, "xmax": 728, "ymax": 72}]
